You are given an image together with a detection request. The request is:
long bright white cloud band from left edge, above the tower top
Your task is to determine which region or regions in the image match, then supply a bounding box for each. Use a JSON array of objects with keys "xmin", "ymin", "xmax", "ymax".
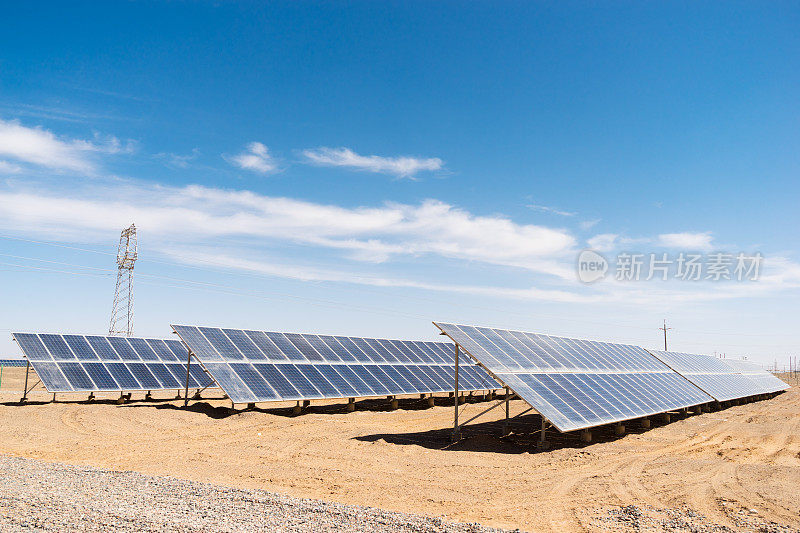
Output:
[{"xmin": 0, "ymin": 180, "xmax": 575, "ymax": 279}]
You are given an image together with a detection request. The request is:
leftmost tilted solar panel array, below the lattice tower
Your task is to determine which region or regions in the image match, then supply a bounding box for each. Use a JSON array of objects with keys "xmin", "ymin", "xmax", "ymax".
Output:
[{"xmin": 14, "ymin": 333, "xmax": 212, "ymax": 392}]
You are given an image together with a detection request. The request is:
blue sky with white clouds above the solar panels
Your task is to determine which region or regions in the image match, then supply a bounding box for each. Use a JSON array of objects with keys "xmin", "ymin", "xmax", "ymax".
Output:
[{"xmin": 0, "ymin": 2, "xmax": 800, "ymax": 362}]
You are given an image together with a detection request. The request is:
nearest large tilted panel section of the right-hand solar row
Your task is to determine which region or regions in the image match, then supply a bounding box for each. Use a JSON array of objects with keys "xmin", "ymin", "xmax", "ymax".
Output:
[{"xmin": 434, "ymin": 323, "xmax": 713, "ymax": 432}]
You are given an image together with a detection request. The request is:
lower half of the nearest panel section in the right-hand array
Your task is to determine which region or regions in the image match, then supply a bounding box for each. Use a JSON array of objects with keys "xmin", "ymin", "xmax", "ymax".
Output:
[{"xmin": 498, "ymin": 372, "xmax": 711, "ymax": 431}]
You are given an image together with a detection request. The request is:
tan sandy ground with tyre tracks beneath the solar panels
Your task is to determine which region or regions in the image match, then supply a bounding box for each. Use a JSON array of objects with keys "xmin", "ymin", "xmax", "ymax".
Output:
[{"xmin": 0, "ymin": 368, "xmax": 800, "ymax": 532}]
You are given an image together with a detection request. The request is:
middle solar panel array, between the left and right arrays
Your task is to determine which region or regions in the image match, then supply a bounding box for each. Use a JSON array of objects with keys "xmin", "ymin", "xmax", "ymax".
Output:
[{"xmin": 172, "ymin": 325, "xmax": 501, "ymax": 403}]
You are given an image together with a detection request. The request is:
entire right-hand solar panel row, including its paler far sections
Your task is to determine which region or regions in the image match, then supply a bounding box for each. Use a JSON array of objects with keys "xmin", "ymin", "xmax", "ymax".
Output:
[{"xmin": 435, "ymin": 323, "xmax": 787, "ymax": 431}]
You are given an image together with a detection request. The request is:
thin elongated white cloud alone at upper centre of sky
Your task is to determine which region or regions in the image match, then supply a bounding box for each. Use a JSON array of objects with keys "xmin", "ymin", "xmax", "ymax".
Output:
[{"xmin": 303, "ymin": 147, "xmax": 444, "ymax": 178}]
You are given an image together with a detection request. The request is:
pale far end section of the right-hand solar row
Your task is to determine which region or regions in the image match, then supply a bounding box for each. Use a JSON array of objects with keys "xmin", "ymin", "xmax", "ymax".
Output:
[{"xmin": 650, "ymin": 350, "xmax": 788, "ymax": 402}]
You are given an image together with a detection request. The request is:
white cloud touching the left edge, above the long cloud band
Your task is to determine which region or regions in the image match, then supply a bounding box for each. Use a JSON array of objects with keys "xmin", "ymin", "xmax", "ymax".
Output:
[{"xmin": 0, "ymin": 120, "xmax": 130, "ymax": 173}]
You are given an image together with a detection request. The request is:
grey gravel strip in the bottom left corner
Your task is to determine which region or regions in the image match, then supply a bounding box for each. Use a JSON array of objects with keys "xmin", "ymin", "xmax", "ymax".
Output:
[{"xmin": 0, "ymin": 456, "xmax": 512, "ymax": 533}]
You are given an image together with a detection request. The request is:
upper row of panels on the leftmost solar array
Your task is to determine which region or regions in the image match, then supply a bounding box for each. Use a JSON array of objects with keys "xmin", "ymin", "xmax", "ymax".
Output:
[{"xmin": 14, "ymin": 333, "xmax": 188, "ymax": 362}]
